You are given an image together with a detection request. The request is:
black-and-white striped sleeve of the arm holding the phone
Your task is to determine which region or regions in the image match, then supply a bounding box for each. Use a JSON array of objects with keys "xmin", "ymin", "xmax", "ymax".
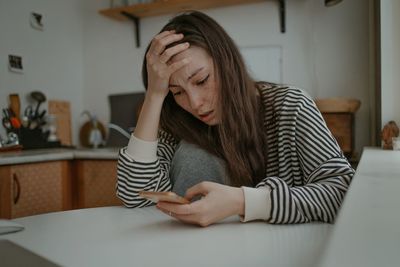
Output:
[{"xmin": 257, "ymin": 90, "xmax": 354, "ymax": 224}]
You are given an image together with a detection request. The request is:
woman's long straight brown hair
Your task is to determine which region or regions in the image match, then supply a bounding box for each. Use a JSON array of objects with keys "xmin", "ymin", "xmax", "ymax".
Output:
[{"xmin": 142, "ymin": 11, "xmax": 266, "ymax": 186}]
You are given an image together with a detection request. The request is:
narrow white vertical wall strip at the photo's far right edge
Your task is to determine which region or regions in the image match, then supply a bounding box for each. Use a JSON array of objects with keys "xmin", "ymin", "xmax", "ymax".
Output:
[{"xmin": 381, "ymin": 0, "xmax": 400, "ymax": 126}]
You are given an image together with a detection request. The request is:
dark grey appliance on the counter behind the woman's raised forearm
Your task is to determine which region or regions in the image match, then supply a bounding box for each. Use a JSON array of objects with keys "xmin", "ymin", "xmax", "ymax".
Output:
[{"xmin": 106, "ymin": 92, "xmax": 145, "ymax": 147}]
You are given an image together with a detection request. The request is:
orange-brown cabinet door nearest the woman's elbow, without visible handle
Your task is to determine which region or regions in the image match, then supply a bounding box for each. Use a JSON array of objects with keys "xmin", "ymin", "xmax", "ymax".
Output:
[{"xmin": 74, "ymin": 160, "xmax": 122, "ymax": 208}]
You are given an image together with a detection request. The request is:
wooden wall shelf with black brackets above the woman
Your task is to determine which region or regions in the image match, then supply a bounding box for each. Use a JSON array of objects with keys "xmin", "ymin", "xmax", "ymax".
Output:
[{"xmin": 99, "ymin": 0, "xmax": 286, "ymax": 47}]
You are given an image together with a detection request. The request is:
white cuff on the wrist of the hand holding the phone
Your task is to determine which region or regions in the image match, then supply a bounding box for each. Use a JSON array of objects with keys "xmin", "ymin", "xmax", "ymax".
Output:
[{"xmin": 240, "ymin": 186, "xmax": 271, "ymax": 222}]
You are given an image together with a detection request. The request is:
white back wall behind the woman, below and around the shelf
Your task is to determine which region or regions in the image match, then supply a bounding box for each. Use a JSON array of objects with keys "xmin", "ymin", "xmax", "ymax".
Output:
[{"xmin": 84, "ymin": 0, "xmax": 371, "ymax": 155}]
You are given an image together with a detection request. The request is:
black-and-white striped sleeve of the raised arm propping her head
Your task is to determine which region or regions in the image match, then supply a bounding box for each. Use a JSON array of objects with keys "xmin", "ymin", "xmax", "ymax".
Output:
[{"xmin": 116, "ymin": 131, "xmax": 176, "ymax": 208}]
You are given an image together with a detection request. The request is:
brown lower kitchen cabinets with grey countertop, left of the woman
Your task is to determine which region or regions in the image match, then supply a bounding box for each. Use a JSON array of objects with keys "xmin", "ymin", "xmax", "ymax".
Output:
[{"xmin": 0, "ymin": 149, "xmax": 122, "ymax": 219}]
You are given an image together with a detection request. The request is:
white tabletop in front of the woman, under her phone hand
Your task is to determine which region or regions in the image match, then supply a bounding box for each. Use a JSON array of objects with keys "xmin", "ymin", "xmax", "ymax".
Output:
[{"xmin": 0, "ymin": 207, "xmax": 333, "ymax": 267}]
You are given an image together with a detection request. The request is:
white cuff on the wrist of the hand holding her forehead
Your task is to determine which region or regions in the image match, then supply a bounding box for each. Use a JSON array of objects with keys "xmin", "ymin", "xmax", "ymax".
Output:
[{"xmin": 126, "ymin": 134, "xmax": 158, "ymax": 162}]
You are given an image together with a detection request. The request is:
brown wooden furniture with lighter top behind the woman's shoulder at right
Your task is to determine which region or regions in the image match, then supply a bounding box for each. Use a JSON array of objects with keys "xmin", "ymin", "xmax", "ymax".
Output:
[{"xmin": 315, "ymin": 98, "xmax": 361, "ymax": 159}]
